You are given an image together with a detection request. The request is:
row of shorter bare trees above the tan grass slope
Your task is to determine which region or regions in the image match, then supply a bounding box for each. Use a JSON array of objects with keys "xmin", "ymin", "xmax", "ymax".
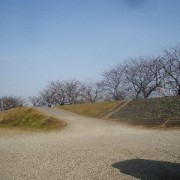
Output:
[{"xmin": 30, "ymin": 79, "xmax": 101, "ymax": 106}]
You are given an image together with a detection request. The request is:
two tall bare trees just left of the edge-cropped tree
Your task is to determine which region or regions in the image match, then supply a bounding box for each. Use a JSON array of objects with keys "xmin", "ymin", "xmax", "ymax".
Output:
[{"xmin": 103, "ymin": 57, "xmax": 163, "ymax": 100}]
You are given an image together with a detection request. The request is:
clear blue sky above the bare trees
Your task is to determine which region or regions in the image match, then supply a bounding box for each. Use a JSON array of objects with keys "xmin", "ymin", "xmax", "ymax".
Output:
[{"xmin": 0, "ymin": 0, "xmax": 180, "ymax": 97}]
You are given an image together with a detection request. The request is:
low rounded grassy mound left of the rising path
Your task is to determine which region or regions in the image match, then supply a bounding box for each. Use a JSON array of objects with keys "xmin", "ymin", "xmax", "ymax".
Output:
[{"xmin": 0, "ymin": 107, "xmax": 65, "ymax": 130}]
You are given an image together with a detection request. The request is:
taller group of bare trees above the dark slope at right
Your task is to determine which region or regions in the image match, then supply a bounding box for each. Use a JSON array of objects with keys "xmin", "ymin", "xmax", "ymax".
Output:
[{"xmin": 102, "ymin": 46, "xmax": 180, "ymax": 100}]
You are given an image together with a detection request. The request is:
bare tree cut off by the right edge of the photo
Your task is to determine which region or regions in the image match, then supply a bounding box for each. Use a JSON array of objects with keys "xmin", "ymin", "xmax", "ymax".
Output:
[{"xmin": 163, "ymin": 46, "xmax": 180, "ymax": 95}]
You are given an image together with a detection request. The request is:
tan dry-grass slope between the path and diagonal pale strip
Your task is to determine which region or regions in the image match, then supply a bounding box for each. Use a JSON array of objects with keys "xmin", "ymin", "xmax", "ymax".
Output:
[{"xmin": 59, "ymin": 101, "xmax": 121, "ymax": 117}]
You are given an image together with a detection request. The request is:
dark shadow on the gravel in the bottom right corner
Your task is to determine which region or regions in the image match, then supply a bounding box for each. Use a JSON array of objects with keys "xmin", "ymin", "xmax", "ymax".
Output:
[{"xmin": 112, "ymin": 159, "xmax": 180, "ymax": 180}]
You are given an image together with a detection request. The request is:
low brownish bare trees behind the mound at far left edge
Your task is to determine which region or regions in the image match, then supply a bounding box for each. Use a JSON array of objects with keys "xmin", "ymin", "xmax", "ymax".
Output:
[{"xmin": 0, "ymin": 96, "xmax": 26, "ymax": 110}]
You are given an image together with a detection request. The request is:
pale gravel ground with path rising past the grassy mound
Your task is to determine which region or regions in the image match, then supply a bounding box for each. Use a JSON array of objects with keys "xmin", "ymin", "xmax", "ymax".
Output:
[{"xmin": 0, "ymin": 108, "xmax": 180, "ymax": 180}]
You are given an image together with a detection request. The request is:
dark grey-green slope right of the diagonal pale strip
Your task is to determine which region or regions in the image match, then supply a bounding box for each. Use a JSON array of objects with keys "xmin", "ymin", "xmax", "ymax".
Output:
[{"xmin": 110, "ymin": 96, "xmax": 180, "ymax": 126}]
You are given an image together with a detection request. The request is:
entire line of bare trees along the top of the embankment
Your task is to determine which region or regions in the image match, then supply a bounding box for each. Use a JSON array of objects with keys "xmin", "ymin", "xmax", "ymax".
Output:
[{"xmin": 0, "ymin": 46, "xmax": 180, "ymax": 109}]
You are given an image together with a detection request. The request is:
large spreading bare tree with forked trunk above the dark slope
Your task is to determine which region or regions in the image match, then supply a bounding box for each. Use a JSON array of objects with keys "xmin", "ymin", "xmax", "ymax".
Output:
[{"xmin": 125, "ymin": 57, "xmax": 163, "ymax": 99}]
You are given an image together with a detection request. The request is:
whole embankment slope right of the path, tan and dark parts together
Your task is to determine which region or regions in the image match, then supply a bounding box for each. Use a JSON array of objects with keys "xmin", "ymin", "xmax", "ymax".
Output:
[{"xmin": 58, "ymin": 96, "xmax": 180, "ymax": 127}]
